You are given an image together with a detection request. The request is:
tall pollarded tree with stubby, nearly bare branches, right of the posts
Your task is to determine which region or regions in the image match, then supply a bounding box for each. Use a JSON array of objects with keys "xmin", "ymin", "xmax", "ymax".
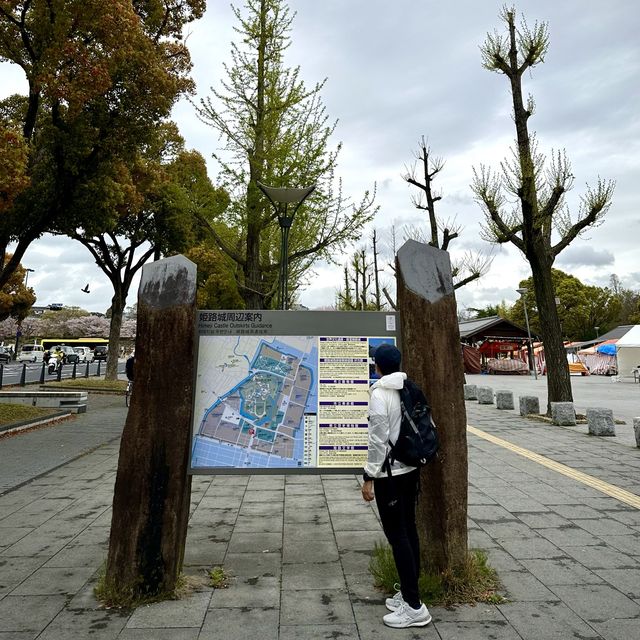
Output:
[{"xmin": 472, "ymin": 8, "xmax": 614, "ymax": 406}]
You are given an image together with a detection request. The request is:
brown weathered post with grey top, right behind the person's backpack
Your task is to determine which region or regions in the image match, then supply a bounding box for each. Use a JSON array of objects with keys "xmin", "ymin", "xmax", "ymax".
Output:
[{"xmin": 396, "ymin": 240, "xmax": 468, "ymax": 572}]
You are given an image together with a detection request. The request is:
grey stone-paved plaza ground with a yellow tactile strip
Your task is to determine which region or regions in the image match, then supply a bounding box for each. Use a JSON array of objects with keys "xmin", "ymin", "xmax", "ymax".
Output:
[{"xmin": 0, "ymin": 376, "xmax": 640, "ymax": 640}]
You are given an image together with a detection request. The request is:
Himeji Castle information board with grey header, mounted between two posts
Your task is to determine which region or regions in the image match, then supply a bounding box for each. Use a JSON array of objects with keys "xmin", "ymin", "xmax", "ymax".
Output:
[{"xmin": 190, "ymin": 311, "xmax": 398, "ymax": 473}]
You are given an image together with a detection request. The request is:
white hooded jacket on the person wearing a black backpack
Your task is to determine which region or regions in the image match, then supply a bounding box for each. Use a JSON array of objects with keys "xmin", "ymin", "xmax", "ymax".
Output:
[{"xmin": 364, "ymin": 371, "xmax": 415, "ymax": 478}]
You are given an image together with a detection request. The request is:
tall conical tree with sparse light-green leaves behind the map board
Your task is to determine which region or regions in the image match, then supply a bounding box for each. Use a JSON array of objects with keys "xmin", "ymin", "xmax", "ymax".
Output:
[{"xmin": 198, "ymin": 0, "xmax": 375, "ymax": 309}]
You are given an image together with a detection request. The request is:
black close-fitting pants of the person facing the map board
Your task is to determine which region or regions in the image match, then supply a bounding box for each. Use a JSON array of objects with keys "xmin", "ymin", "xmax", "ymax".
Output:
[{"xmin": 373, "ymin": 469, "xmax": 420, "ymax": 609}]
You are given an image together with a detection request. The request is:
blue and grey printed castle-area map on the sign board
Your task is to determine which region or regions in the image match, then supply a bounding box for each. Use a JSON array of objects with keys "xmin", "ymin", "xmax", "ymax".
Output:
[{"xmin": 191, "ymin": 335, "xmax": 318, "ymax": 468}]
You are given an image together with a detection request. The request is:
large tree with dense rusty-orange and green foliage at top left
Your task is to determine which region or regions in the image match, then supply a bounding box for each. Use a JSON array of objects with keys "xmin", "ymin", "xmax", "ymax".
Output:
[{"xmin": 0, "ymin": 0, "xmax": 205, "ymax": 286}]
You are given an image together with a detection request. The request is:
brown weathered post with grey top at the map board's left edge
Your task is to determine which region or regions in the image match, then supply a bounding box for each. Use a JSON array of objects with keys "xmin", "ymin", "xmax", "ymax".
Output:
[{"xmin": 105, "ymin": 256, "xmax": 196, "ymax": 601}]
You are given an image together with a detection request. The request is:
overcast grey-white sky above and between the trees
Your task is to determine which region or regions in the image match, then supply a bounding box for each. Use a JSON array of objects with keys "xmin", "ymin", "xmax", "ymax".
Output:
[{"xmin": 0, "ymin": 0, "xmax": 640, "ymax": 311}]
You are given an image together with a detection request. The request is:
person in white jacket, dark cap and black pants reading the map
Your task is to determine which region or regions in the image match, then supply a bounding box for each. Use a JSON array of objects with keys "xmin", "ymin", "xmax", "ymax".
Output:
[{"xmin": 362, "ymin": 344, "xmax": 431, "ymax": 629}]
